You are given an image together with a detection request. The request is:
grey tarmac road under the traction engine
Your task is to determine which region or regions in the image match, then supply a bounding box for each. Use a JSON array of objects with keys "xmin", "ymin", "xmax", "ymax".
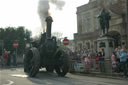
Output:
[{"xmin": 0, "ymin": 68, "xmax": 128, "ymax": 85}]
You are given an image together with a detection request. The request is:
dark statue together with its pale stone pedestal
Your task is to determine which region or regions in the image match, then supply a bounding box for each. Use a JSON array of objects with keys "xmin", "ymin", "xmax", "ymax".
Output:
[{"xmin": 97, "ymin": 9, "xmax": 114, "ymax": 73}]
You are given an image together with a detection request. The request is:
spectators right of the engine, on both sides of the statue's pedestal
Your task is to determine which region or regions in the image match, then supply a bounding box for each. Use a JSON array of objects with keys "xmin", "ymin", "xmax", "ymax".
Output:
[{"xmin": 68, "ymin": 46, "xmax": 128, "ymax": 76}]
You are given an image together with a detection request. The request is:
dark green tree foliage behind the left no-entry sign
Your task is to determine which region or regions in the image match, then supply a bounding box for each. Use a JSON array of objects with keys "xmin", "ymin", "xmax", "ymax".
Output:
[{"xmin": 0, "ymin": 26, "xmax": 31, "ymax": 54}]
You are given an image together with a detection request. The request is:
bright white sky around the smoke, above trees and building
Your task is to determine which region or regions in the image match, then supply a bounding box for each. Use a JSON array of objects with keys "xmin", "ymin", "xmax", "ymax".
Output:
[{"xmin": 0, "ymin": 0, "xmax": 89, "ymax": 39}]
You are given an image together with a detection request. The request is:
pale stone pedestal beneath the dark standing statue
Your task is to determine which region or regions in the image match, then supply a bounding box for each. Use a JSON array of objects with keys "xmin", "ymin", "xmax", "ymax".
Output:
[{"xmin": 97, "ymin": 36, "xmax": 114, "ymax": 73}]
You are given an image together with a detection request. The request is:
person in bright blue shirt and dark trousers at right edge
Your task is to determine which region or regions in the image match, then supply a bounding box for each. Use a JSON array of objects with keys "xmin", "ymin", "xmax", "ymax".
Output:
[{"xmin": 120, "ymin": 48, "xmax": 127, "ymax": 77}]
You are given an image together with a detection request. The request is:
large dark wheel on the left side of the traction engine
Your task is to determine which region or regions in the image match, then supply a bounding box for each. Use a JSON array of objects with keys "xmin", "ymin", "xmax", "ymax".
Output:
[{"xmin": 24, "ymin": 48, "xmax": 40, "ymax": 77}]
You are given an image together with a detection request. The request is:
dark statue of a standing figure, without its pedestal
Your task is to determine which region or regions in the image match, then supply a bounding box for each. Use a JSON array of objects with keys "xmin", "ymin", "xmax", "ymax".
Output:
[{"xmin": 98, "ymin": 9, "xmax": 111, "ymax": 35}]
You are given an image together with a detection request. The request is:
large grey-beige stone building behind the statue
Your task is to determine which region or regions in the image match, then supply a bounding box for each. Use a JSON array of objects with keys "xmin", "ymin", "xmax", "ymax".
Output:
[{"xmin": 74, "ymin": 0, "xmax": 128, "ymax": 51}]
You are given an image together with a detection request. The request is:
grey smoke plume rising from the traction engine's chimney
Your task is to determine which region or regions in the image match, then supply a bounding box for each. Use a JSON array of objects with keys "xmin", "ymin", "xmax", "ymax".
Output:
[{"xmin": 38, "ymin": 0, "xmax": 65, "ymax": 32}]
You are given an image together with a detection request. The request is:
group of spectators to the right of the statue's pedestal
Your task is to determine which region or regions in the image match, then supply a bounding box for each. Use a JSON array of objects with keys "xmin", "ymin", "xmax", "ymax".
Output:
[{"xmin": 111, "ymin": 46, "xmax": 128, "ymax": 77}]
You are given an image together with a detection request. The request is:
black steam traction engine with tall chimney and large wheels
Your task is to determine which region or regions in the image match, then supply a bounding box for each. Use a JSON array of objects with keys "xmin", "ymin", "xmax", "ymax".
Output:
[{"xmin": 24, "ymin": 16, "xmax": 69, "ymax": 77}]
